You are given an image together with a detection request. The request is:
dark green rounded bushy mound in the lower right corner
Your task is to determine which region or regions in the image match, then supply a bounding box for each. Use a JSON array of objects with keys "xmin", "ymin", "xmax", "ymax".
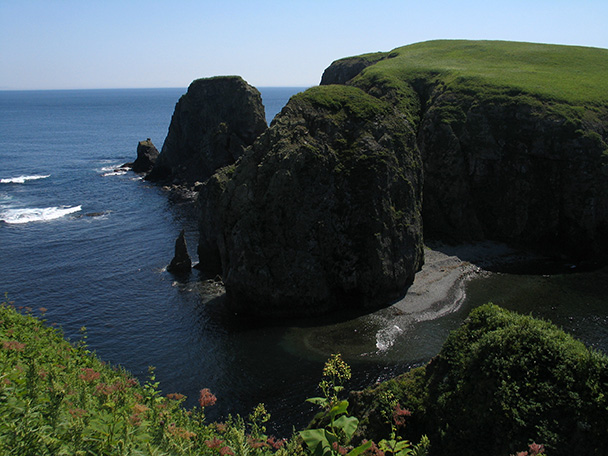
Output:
[{"xmin": 351, "ymin": 304, "xmax": 608, "ymax": 456}]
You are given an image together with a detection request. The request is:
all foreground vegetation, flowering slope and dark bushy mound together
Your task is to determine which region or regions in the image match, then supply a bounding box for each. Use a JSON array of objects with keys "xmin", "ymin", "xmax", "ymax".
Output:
[{"xmin": 0, "ymin": 303, "xmax": 608, "ymax": 456}]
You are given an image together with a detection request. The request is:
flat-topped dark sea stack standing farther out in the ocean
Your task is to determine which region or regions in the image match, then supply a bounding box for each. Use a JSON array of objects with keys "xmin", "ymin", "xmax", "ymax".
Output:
[{"xmin": 146, "ymin": 76, "xmax": 267, "ymax": 184}]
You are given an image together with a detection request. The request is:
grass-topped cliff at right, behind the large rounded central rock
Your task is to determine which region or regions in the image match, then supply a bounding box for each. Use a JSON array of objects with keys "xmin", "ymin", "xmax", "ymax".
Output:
[{"xmin": 324, "ymin": 41, "xmax": 608, "ymax": 261}]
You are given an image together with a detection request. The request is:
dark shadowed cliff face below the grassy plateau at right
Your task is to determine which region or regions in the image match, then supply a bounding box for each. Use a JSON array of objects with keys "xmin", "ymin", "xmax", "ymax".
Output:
[{"xmin": 418, "ymin": 87, "xmax": 608, "ymax": 259}]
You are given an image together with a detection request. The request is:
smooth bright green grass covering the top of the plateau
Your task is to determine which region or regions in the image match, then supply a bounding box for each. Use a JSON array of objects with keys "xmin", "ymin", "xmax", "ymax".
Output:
[{"xmin": 360, "ymin": 40, "xmax": 608, "ymax": 104}]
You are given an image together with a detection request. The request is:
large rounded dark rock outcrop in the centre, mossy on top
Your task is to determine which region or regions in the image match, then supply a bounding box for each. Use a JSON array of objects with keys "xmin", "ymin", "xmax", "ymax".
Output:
[{"xmin": 199, "ymin": 86, "xmax": 423, "ymax": 316}]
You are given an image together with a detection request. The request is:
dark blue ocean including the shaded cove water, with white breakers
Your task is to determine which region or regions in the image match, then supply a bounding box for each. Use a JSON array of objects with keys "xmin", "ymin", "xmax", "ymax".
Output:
[{"xmin": 0, "ymin": 87, "xmax": 608, "ymax": 435}]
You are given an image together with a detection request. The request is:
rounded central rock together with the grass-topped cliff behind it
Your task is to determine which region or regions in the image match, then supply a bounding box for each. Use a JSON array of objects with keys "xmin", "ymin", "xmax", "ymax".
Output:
[{"xmin": 196, "ymin": 41, "xmax": 608, "ymax": 315}]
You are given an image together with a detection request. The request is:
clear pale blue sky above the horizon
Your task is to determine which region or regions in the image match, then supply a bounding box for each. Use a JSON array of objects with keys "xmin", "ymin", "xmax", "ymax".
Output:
[{"xmin": 0, "ymin": 0, "xmax": 608, "ymax": 90}]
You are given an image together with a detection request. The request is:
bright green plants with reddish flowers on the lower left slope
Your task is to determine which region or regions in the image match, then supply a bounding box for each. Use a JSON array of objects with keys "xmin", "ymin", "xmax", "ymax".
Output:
[{"xmin": 0, "ymin": 303, "xmax": 428, "ymax": 456}]
